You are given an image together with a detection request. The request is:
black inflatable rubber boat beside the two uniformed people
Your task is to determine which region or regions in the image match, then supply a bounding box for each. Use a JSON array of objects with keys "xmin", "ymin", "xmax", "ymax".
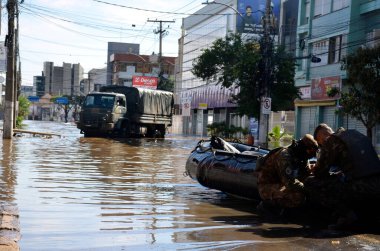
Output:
[{"xmin": 186, "ymin": 137, "xmax": 269, "ymax": 200}]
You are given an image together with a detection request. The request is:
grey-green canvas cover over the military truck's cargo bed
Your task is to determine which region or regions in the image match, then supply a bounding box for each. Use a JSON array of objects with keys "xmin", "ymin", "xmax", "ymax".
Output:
[{"xmin": 100, "ymin": 85, "xmax": 174, "ymax": 116}]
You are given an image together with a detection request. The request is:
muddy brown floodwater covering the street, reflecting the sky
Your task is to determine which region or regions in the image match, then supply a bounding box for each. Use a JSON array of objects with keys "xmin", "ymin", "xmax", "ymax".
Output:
[{"xmin": 0, "ymin": 121, "xmax": 380, "ymax": 251}]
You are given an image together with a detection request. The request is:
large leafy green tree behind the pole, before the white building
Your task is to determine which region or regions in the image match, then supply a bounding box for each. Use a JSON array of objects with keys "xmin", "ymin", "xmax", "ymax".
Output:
[{"xmin": 192, "ymin": 33, "xmax": 299, "ymax": 118}]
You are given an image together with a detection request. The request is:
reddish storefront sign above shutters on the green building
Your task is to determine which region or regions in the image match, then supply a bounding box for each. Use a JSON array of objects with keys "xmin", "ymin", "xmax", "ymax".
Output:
[{"xmin": 311, "ymin": 76, "xmax": 341, "ymax": 100}]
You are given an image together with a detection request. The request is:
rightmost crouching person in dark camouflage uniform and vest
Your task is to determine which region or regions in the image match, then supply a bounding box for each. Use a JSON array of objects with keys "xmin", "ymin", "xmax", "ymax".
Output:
[{"xmin": 304, "ymin": 124, "xmax": 380, "ymax": 228}]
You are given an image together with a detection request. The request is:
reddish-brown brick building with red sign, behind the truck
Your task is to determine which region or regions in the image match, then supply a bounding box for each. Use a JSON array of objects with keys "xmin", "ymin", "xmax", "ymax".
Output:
[{"xmin": 110, "ymin": 53, "xmax": 176, "ymax": 88}]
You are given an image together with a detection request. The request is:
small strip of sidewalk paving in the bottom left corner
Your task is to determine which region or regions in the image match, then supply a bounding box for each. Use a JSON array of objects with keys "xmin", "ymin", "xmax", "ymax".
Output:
[{"xmin": 0, "ymin": 202, "xmax": 21, "ymax": 251}]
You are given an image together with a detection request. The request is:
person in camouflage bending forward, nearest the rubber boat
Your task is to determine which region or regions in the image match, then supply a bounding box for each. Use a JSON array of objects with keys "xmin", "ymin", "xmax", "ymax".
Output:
[{"xmin": 257, "ymin": 134, "xmax": 318, "ymax": 208}]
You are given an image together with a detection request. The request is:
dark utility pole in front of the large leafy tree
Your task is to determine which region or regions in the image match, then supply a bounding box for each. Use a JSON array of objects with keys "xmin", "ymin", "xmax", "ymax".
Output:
[{"xmin": 259, "ymin": 0, "xmax": 273, "ymax": 147}]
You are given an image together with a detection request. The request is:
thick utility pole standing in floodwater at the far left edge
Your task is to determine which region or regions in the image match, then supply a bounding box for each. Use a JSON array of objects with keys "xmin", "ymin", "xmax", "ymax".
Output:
[{"xmin": 3, "ymin": 0, "xmax": 17, "ymax": 139}]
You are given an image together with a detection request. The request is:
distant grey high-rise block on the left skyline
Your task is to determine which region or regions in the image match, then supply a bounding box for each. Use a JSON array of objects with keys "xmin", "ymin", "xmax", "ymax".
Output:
[{"xmin": 40, "ymin": 62, "xmax": 83, "ymax": 96}]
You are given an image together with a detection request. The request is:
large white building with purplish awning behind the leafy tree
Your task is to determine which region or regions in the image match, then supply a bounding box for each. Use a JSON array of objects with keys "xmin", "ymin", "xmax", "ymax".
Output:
[{"xmin": 173, "ymin": 0, "xmax": 290, "ymax": 136}]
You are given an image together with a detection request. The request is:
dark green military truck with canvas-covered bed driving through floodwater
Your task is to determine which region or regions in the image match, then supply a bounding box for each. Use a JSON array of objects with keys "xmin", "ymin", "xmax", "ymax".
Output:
[{"xmin": 77, "ymin": 85, "xmax": 174, "ymax": 137}]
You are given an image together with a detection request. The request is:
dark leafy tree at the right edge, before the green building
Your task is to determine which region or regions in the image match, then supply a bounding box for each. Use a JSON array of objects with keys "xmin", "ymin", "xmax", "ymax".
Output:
[{"xmin": 329, "ymin": 46, "xmax": 380, "ymax": 139}]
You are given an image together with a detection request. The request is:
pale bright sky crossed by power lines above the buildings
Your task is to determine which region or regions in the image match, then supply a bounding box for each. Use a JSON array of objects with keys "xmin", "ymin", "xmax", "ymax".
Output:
[{"xmin": 6, "ymin": 0, "xmax": 205, "ymax": 85}]
